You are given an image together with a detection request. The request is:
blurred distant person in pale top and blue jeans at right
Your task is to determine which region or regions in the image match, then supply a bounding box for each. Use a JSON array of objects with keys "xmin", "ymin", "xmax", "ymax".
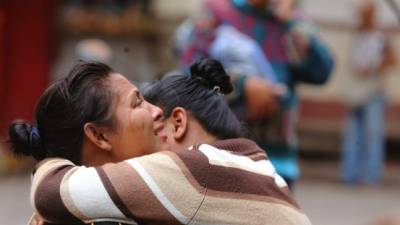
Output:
[{"xmin": 342, "ymin": 1, "xmax": 396, "ymax": 185}]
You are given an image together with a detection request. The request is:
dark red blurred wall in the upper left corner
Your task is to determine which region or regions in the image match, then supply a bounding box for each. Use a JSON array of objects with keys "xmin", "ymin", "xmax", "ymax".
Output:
[{"xmin": 0, "ymin": 0, "xmax": 55, "ymax": 137}]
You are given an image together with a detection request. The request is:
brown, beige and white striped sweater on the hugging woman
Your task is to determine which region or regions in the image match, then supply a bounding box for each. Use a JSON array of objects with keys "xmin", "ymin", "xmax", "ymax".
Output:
[{"xmin": 31, "ymin": 139, "xmax": 311, "ymax": 225}]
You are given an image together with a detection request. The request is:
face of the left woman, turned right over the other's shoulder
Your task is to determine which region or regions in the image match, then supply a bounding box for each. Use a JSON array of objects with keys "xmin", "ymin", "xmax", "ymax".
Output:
[{"xmin": 106, "ymin": 73, "xmax": 166, "ymax": 161}]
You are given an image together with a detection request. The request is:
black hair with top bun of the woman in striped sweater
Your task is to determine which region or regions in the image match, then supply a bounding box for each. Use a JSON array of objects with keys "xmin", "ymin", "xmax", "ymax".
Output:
[{"xmin": 144, "ymin": 58, "xmax": 242, "ymax": 139}]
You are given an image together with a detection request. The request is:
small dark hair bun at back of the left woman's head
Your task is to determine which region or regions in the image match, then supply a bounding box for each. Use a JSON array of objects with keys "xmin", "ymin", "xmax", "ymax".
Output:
[{"xmin": 8, "ymin": 120, "xmax": 46, "ymax": 160}]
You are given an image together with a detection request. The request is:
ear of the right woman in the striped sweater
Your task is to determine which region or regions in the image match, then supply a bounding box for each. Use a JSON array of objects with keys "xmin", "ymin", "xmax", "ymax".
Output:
[{"xmin": 170, "ymin": 107, "xmax": 188, "ymax": 142}]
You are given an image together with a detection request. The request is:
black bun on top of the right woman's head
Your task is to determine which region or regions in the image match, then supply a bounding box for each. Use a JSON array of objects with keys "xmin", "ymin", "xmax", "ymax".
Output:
[{"xmin": 190, "ymin": 58, "xmax": 233, "ymax": 94}]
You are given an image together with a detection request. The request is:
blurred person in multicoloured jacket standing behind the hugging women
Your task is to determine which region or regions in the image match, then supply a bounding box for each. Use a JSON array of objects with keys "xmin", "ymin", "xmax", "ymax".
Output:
[{"xmin": 176, "ymin": 0, "xmax": 333, "ymax": 186}]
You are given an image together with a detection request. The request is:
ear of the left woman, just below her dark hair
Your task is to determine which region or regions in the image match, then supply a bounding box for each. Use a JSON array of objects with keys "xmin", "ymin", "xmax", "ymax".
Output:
[{"xmin": 83, "ymin": 123, "xmax": 112, "ymax": 151}]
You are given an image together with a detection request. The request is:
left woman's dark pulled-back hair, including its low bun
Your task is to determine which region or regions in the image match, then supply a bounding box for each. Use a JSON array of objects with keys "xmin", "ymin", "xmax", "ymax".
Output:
[{"xmin": 8, "ymin": 62, "xmax": 114, "ymax": 164}]
